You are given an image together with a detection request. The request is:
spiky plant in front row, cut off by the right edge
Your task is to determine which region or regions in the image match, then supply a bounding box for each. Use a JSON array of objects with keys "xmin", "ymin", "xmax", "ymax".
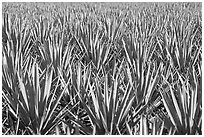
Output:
[{"xmin": 160, "ymin": 60, "xmax": 202, "ymax": 134}]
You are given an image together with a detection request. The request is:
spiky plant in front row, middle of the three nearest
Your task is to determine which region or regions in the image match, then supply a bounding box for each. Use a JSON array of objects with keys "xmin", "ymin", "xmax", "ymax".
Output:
[{"xmin": 59, "ymin": 60, "xmax": 134, "ymax": 134}]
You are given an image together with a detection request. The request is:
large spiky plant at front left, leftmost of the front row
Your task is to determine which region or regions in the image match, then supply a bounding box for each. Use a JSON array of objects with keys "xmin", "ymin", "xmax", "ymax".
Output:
[{"xmin": 3, "ymin": 60, "xmax": 67, "ymax": 134}]
